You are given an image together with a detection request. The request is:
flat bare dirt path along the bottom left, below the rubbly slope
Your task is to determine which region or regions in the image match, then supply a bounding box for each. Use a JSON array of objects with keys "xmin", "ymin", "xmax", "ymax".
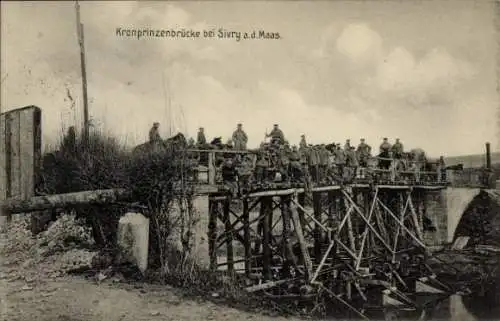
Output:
[{"xmin": 0, "ymin": 277, "xmax": 300, "ymax": 321}]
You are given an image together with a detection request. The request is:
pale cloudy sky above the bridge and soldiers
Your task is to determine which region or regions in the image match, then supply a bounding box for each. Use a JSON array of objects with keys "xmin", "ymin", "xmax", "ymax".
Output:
[{"xmin": 1, "ymin": 1, "xmax": 500, "ymax": 156}]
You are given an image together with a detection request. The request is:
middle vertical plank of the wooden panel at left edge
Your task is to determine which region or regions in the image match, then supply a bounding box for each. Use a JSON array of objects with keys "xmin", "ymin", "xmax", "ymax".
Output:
[{"xmin": 7, "ymin": 111, "xmax": 22, "ymax": 198}]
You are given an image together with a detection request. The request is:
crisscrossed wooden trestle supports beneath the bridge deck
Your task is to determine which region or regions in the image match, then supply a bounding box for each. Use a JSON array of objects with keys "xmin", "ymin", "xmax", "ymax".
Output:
[{"xmin": 209, "ymin": 185, "xmax": 449, "ymax": 318}]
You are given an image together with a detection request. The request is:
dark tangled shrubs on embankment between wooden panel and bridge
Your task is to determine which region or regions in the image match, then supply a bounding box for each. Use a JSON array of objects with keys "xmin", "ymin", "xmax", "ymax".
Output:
[{"xmin": 37, "ymin": 129, "xmax": 195, "ymax": 267}]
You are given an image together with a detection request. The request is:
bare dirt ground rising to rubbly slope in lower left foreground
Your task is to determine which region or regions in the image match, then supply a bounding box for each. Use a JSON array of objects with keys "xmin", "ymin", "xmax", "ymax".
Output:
[{"xmin": 0, "ymin": 218, "xmax": 299, "ymax": 321}]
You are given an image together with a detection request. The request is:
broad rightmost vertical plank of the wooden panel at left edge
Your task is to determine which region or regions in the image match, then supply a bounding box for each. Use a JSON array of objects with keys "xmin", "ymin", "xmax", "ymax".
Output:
[{"xmin": 19, "ymin": 108, "xmax": 35, "ymax": 198}]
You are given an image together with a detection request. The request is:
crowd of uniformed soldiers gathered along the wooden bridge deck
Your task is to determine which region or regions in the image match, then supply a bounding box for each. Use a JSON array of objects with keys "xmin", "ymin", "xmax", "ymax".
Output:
[{"xmin": 150, "ymin": 123, "xmax": 442, "ymax": 195}]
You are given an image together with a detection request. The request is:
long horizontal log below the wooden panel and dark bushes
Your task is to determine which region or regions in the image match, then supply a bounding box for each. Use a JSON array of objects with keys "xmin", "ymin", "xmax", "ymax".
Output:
[{"xmin": 0, "ymin": 189, "xmax": 131, "ymax": 216}]
